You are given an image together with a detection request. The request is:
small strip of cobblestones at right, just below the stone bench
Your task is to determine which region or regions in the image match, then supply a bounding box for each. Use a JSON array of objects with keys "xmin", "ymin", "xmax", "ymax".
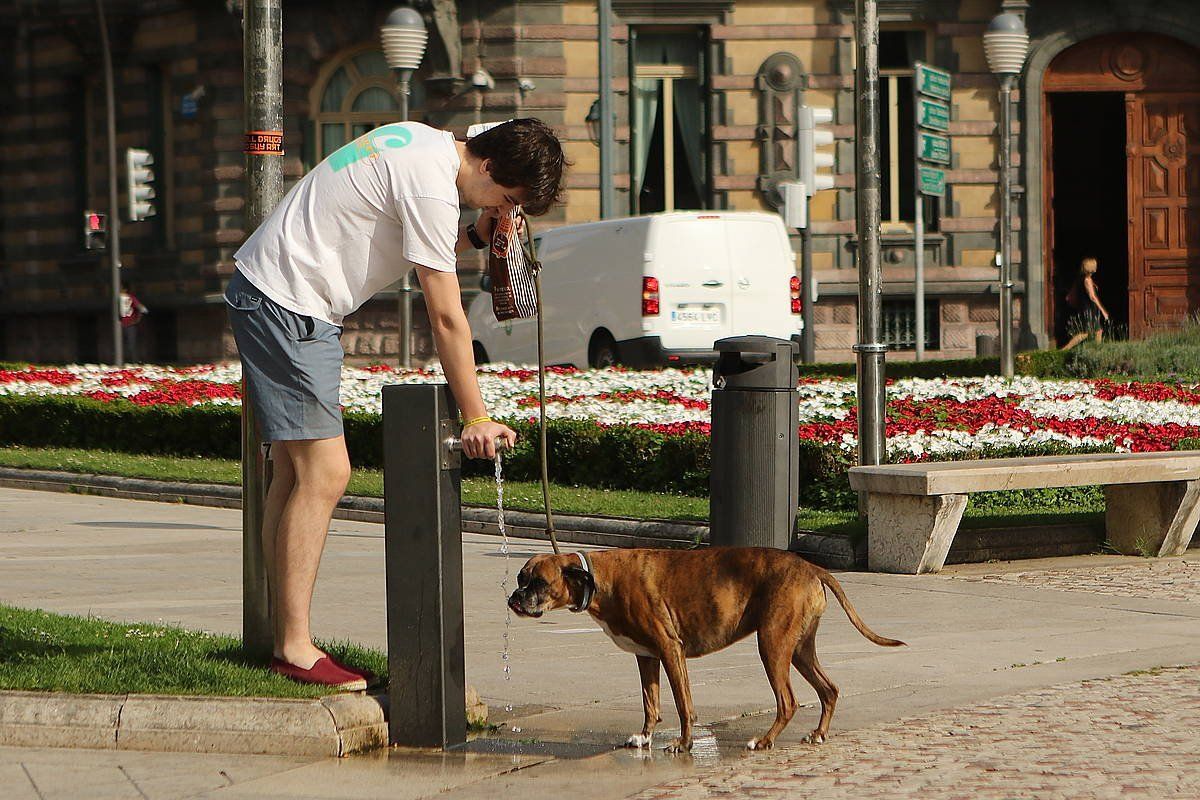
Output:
[{"xmin": 949, "ymin": 559, "xmax": 1200, "ymax": 603}]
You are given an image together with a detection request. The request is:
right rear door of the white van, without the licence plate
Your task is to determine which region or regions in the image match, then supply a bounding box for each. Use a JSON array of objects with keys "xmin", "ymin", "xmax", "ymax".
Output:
[{"xmin": 725, "ymin": 215, "xmax": 799, "ymax": 338}]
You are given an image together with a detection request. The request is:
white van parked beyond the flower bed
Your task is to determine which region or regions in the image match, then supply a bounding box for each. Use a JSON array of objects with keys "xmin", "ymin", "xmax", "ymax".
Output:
[{"xmin": 468, "ymin": 211, "xmax": 802, "ymax": 368}]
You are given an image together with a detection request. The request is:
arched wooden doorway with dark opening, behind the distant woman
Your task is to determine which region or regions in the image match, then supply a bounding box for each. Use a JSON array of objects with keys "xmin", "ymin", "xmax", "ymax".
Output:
[{"xmin": 1043, "ymin": 34, "xmax": 1200, "ymax": 341}]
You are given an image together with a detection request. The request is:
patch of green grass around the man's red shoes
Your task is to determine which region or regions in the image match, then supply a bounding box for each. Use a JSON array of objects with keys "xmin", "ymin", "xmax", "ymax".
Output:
[{"xmin": 0, "ymin": 606, "xmax": 388, "ymax": 697}]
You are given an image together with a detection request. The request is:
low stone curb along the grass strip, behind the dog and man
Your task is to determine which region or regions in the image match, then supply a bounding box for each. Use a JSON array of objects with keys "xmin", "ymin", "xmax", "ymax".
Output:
[{"xmin": 0, "ymin": 467, "xmax": 866, "ymax": 570}]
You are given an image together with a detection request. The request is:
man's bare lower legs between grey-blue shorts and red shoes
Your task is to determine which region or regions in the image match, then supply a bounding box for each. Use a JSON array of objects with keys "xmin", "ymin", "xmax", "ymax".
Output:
[{"xmin": 263, "ymin": 437, "xmax": 350, "ymax": 669}]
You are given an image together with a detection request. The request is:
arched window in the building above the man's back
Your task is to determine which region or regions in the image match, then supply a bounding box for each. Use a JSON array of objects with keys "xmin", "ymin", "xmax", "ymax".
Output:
[{"xmin": 310, "ymin": 44, "xmax": 425, "ymax": 162}]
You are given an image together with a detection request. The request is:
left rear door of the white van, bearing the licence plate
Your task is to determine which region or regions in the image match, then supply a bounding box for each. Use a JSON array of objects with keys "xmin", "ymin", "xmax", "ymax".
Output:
[{"xmin": 646, "ymin": 215, "xmax": 733, "ymax": 350}]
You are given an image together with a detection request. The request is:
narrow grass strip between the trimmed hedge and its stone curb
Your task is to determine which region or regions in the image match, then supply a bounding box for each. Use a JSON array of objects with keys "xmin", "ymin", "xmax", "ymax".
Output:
[{"xmin": 0, "ymin": 447, "xmax": 1104, "ymax": 537}]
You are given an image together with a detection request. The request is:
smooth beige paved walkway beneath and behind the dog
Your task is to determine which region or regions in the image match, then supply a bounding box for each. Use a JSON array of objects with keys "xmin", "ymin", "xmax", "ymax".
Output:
[{"xmin": 0, "ymin": 489, "xmax": 1200, "ymax": 800}]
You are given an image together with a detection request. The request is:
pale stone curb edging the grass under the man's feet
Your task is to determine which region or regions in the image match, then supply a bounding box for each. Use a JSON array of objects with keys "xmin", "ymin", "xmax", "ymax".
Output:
[{"xmin": 0, "ymin": 691, "xmax": 388, "ymax": 757}]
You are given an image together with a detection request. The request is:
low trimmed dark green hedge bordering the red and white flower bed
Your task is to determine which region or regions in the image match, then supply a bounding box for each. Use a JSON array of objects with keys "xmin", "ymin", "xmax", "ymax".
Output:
[{"xmin": 0, "ymin": 396, "xmax": 1132, "ymax": 510}]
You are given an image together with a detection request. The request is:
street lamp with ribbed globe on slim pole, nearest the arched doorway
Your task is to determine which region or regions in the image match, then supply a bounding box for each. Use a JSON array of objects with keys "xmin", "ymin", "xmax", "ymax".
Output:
[{"xmin": 983, "ymin": 13, "xmax": 1030, "ymax": 378}]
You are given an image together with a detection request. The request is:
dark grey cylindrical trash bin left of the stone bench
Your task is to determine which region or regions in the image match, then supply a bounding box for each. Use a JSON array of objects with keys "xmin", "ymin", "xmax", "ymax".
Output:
[{"xmin": 709, "ymin": 336, "xmax": 800, "ymax": 549}]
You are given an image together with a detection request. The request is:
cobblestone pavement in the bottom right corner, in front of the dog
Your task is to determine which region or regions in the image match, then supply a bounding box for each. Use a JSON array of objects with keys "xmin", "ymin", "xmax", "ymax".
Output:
[{"xmin": 635, "ymin": 667, "xmax": 1200, "ymax": 800}]
